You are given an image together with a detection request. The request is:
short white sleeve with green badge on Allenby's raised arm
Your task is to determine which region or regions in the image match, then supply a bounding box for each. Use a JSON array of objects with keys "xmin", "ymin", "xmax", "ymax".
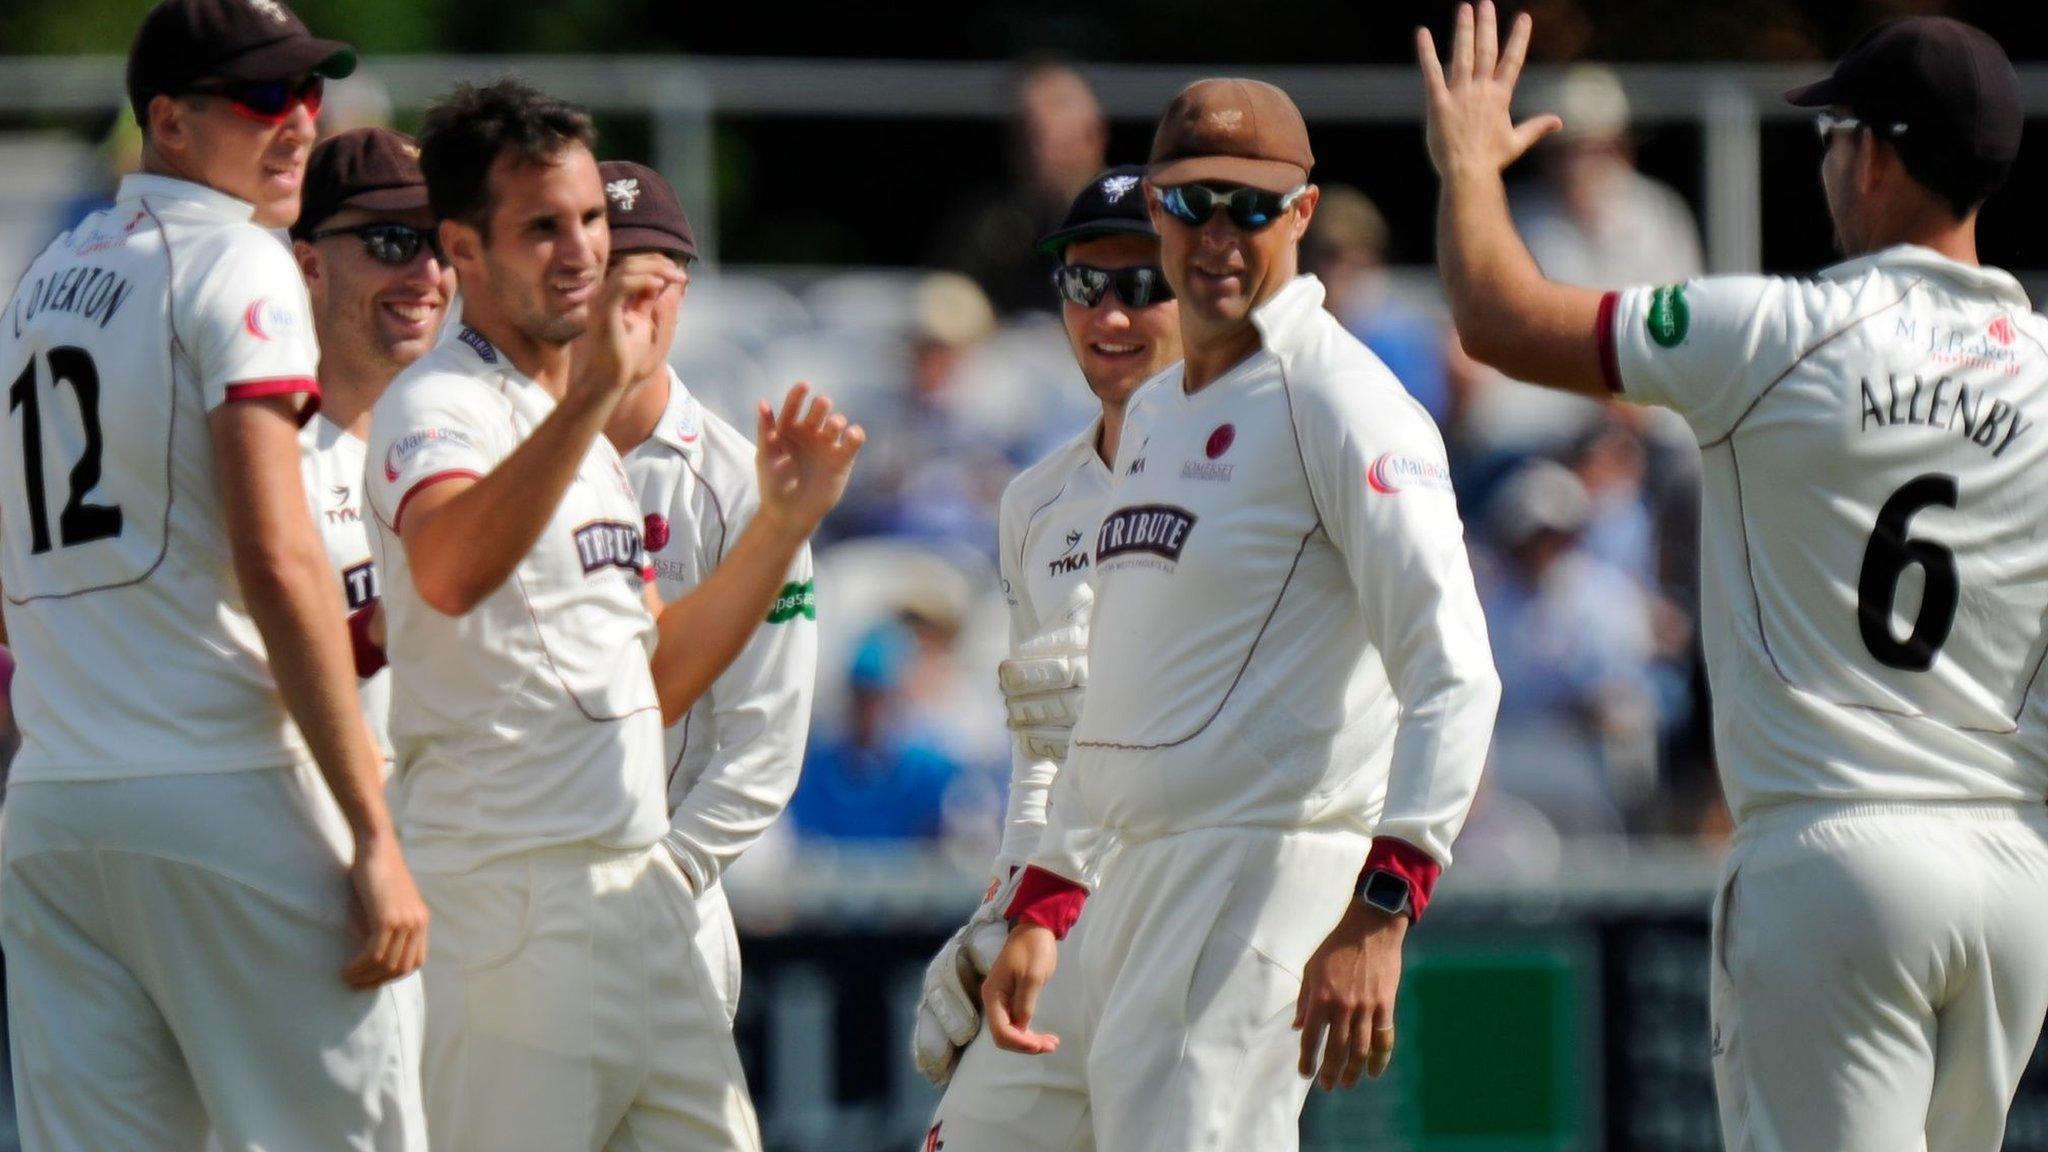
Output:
[{"xmin": 1595, "ymin": 277, "xmax": 1806, "ymax": 443}]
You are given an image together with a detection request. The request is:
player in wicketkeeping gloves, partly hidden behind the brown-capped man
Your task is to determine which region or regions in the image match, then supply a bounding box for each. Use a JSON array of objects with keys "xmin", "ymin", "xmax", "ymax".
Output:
[{"xmin": 913, "ymin": 164, "xmax": 1180, "ymax": 1152}]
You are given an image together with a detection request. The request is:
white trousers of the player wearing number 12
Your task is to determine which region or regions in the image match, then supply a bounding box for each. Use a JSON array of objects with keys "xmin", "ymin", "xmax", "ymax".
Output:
[{"xmin": 0, "ymin": 765, "xmax": 426, "ymax": 1152}]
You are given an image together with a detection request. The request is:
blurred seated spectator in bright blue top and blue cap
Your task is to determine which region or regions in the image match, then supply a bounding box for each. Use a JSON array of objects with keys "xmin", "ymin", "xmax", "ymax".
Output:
[{"xmin": 788, "ymin": 617, "xmax": 961, "ymax": 842}]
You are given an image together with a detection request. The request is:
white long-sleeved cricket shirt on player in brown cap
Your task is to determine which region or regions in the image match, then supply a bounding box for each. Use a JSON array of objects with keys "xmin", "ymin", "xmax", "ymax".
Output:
[{"xmin": 1032, "ymin": 277, "xmax": 1499, "ymax": 879}]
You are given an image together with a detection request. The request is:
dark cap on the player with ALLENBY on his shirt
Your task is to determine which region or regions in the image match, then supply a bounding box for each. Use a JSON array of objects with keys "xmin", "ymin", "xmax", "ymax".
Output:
[{"xmin": 1786, "ymin": 16, "xmax": 2025, "ymax": 168}]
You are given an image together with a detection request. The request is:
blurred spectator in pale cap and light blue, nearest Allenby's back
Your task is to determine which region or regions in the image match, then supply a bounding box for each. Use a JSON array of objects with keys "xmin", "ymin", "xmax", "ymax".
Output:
[{"xmin": 1473, "ymin": 459, "xmax": 1657, "ymax": 836}]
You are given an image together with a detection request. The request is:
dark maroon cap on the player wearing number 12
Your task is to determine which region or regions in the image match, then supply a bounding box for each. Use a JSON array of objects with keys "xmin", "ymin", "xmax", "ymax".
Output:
[{"xmin": 127, "ymin": 0, "xmax": 356, "ymax": 125}]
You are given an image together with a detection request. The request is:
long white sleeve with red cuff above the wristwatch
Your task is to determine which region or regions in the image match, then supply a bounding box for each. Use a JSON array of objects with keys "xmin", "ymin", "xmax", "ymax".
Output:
[{"xmin": 1294, "ymin": 377, "xmax": 1501, "ymax": 912}]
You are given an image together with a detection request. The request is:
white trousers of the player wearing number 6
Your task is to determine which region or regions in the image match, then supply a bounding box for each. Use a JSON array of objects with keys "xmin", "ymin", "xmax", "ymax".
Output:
[{"xmin": 1712, "ymin": 804, "xmax": 2048, "ymax": 1152}]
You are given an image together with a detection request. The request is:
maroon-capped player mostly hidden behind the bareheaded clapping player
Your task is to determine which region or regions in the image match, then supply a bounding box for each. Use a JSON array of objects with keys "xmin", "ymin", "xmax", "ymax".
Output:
[{"xmin": 598, "ymin": 160, "xmax": 817, "ymax": 1023}]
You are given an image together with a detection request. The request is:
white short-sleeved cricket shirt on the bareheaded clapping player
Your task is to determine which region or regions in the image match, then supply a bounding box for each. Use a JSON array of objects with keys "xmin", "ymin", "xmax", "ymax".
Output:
[{"xmin": 369, "ymin": 324, "xmax": 668, "ymax": 871}]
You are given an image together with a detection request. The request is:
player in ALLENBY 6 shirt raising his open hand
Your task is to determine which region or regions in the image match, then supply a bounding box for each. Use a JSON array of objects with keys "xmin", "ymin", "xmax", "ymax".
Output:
[{"xmin": 1417, "ymin": 4, "xmax": 2048, "ymax": 1152}]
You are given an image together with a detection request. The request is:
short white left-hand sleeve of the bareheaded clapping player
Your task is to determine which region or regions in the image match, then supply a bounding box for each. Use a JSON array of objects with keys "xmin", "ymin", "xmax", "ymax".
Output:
[{"xmin": 365, "ymin": 375, "xmax": 510, "ymax": 531}]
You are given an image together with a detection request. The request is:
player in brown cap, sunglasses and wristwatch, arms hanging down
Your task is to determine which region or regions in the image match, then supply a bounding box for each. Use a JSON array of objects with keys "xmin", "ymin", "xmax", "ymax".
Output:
[{"xmin": 983, "ymin": 80, "xmax": 1499, "ymax": 1150}]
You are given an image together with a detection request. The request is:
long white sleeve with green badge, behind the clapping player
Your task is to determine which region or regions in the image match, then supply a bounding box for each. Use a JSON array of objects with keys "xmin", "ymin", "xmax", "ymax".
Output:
[{"xmin": 668, "ymin": 510, "xmax": 817, "ymax": 892}]
